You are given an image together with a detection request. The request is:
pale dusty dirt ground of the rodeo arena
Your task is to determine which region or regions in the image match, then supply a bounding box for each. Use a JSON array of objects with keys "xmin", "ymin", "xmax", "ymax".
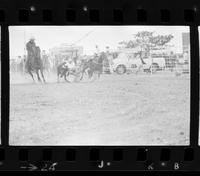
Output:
[{"xmin": 10, "ymin": 73, "xmax": 190, "ymax": 145}]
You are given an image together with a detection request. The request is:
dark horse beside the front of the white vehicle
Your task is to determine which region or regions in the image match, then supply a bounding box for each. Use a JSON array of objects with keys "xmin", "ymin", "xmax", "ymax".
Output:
[{"xmin": 80, "ymin": 52, "xmax": 107, "ymax": 80}]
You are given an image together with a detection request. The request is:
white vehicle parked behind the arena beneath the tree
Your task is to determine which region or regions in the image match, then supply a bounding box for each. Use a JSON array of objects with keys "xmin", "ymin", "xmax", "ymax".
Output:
[{"xmin": 113, "ymin": 53, "xmax": 165, "ymax": 74}]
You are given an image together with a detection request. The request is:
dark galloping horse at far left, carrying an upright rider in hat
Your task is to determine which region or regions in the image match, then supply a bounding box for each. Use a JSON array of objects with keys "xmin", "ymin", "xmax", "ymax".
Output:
[{"xmin": 26, "ymin": 47, "xmax": 46, "ymax": 82}]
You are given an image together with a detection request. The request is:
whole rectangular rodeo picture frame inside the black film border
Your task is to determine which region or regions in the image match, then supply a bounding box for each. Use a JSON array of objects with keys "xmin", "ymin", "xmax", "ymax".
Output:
[{"xmin": 9, "ymin": 25, "xmax": 190, "ymax": 146}]
